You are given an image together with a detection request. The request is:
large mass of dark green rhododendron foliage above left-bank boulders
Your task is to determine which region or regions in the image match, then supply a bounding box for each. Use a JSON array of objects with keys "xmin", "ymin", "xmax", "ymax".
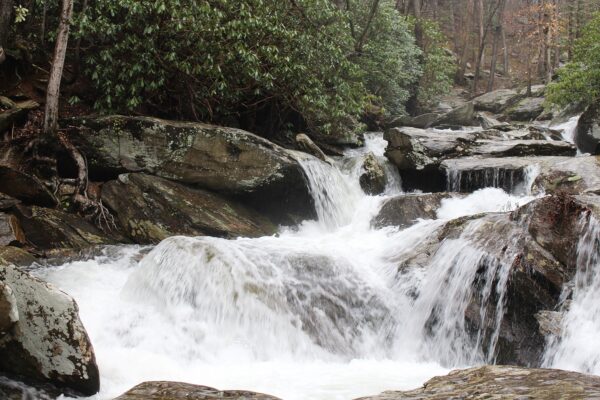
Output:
[{"xmin": 7, "ymin": 0, "xmax": 453, "ymax": 135}]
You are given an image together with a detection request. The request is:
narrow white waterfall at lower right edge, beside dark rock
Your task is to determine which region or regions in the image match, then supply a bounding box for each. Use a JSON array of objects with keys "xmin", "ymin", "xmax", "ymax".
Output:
[{"xmin": 544, "ymin": 217, "xmax": 600, "ymax": 374}]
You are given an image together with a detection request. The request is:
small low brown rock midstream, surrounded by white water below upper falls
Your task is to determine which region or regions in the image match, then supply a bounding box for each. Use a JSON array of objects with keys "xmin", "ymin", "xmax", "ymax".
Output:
[{"xmin": 371, "ymin": 193, "xmax": 452, "ymax": 228}]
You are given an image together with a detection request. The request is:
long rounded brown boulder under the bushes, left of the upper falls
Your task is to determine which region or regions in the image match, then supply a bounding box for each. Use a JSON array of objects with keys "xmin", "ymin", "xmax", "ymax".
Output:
[{"xmin": 70, "ymin": 116, "xmax": 314, "ymax": 223}]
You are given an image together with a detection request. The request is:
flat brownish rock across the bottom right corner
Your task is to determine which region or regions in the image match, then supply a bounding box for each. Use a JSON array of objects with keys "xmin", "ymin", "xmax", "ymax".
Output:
[{"xmin": 357, "ymin": 365, "xmax": 600, "ymax": 400}]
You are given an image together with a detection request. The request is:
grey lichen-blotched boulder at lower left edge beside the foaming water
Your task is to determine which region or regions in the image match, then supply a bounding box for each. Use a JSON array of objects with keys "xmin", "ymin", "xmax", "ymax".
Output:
[{"xmin": 0, "ymin": 264, "xmax": 100, "ymax": 396}]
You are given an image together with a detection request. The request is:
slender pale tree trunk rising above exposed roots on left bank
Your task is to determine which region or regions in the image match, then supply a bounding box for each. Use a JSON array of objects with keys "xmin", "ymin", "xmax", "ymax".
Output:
[{"xmin": 44, "ymin": 0, "xmax": 73, "ymax": 136}]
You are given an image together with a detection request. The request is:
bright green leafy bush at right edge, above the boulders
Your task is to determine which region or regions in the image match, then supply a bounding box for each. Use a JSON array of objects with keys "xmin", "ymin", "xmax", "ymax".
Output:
[{"xmin": 547, "ymin": 13, "xmax": 600, "ymax": 106}]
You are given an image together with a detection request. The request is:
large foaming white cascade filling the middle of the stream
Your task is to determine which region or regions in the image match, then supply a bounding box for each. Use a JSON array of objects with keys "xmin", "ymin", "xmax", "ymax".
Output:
[{"xmin": 37, "ymin": 134, "xmax": 600, "ymax": 400}]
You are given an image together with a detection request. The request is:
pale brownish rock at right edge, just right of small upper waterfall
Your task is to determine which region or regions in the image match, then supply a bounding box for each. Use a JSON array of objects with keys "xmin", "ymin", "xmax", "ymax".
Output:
[{"xmin": 532, "ymin": 156, "xmax": 600, "ymax": 194}]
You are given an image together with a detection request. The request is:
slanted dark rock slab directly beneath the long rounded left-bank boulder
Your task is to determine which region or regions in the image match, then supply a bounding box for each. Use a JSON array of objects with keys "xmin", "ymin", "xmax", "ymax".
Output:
[{"xmin": 102, "ymin": 174, "xmax": 276, "ymax": 243}]
